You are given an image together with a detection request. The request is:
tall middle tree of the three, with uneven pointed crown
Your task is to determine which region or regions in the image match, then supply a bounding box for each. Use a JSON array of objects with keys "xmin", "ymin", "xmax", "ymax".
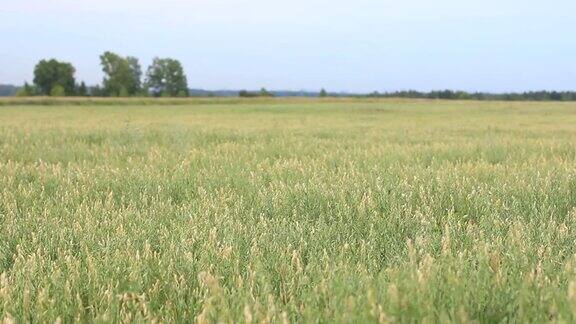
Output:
[{"xmin": 100, "ymin": 52, "xmax": 142, "ymax": 97}]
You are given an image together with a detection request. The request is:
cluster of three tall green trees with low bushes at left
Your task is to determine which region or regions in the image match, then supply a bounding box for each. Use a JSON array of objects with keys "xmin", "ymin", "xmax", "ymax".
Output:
[{"xmin": 18, "ymin": 52, "xmax": 188, "ymax": 97}]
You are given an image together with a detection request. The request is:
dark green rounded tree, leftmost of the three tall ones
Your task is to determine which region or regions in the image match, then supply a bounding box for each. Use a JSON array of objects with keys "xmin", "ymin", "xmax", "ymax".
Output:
[{"xmin": 34, "ymin": 59, "xmax": 76, "ymax": 95}]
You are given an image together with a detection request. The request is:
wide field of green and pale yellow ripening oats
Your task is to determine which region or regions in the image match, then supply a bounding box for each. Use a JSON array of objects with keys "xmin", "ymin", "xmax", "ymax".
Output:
[{"xmin": 0, "ymin": 99, "xmax": 576, "ymax": 323}]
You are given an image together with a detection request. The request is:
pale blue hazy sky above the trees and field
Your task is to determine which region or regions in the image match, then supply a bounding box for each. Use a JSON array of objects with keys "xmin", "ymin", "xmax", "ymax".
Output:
[{"xmin": 0, "ymin": 0, "xmax": 576, "ymax": 92}]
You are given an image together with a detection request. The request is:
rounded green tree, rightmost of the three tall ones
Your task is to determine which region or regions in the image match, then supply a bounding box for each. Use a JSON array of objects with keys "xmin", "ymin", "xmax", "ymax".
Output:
[{"xmin": 146, "ymin": 57, "xmax": 188, "ymax": 97}]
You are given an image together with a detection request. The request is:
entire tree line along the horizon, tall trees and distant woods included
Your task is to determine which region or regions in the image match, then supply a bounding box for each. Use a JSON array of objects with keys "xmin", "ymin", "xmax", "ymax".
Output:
[{"xmin": 12, "ymin": 51, "xmax": 576, "ymax": 101}]
